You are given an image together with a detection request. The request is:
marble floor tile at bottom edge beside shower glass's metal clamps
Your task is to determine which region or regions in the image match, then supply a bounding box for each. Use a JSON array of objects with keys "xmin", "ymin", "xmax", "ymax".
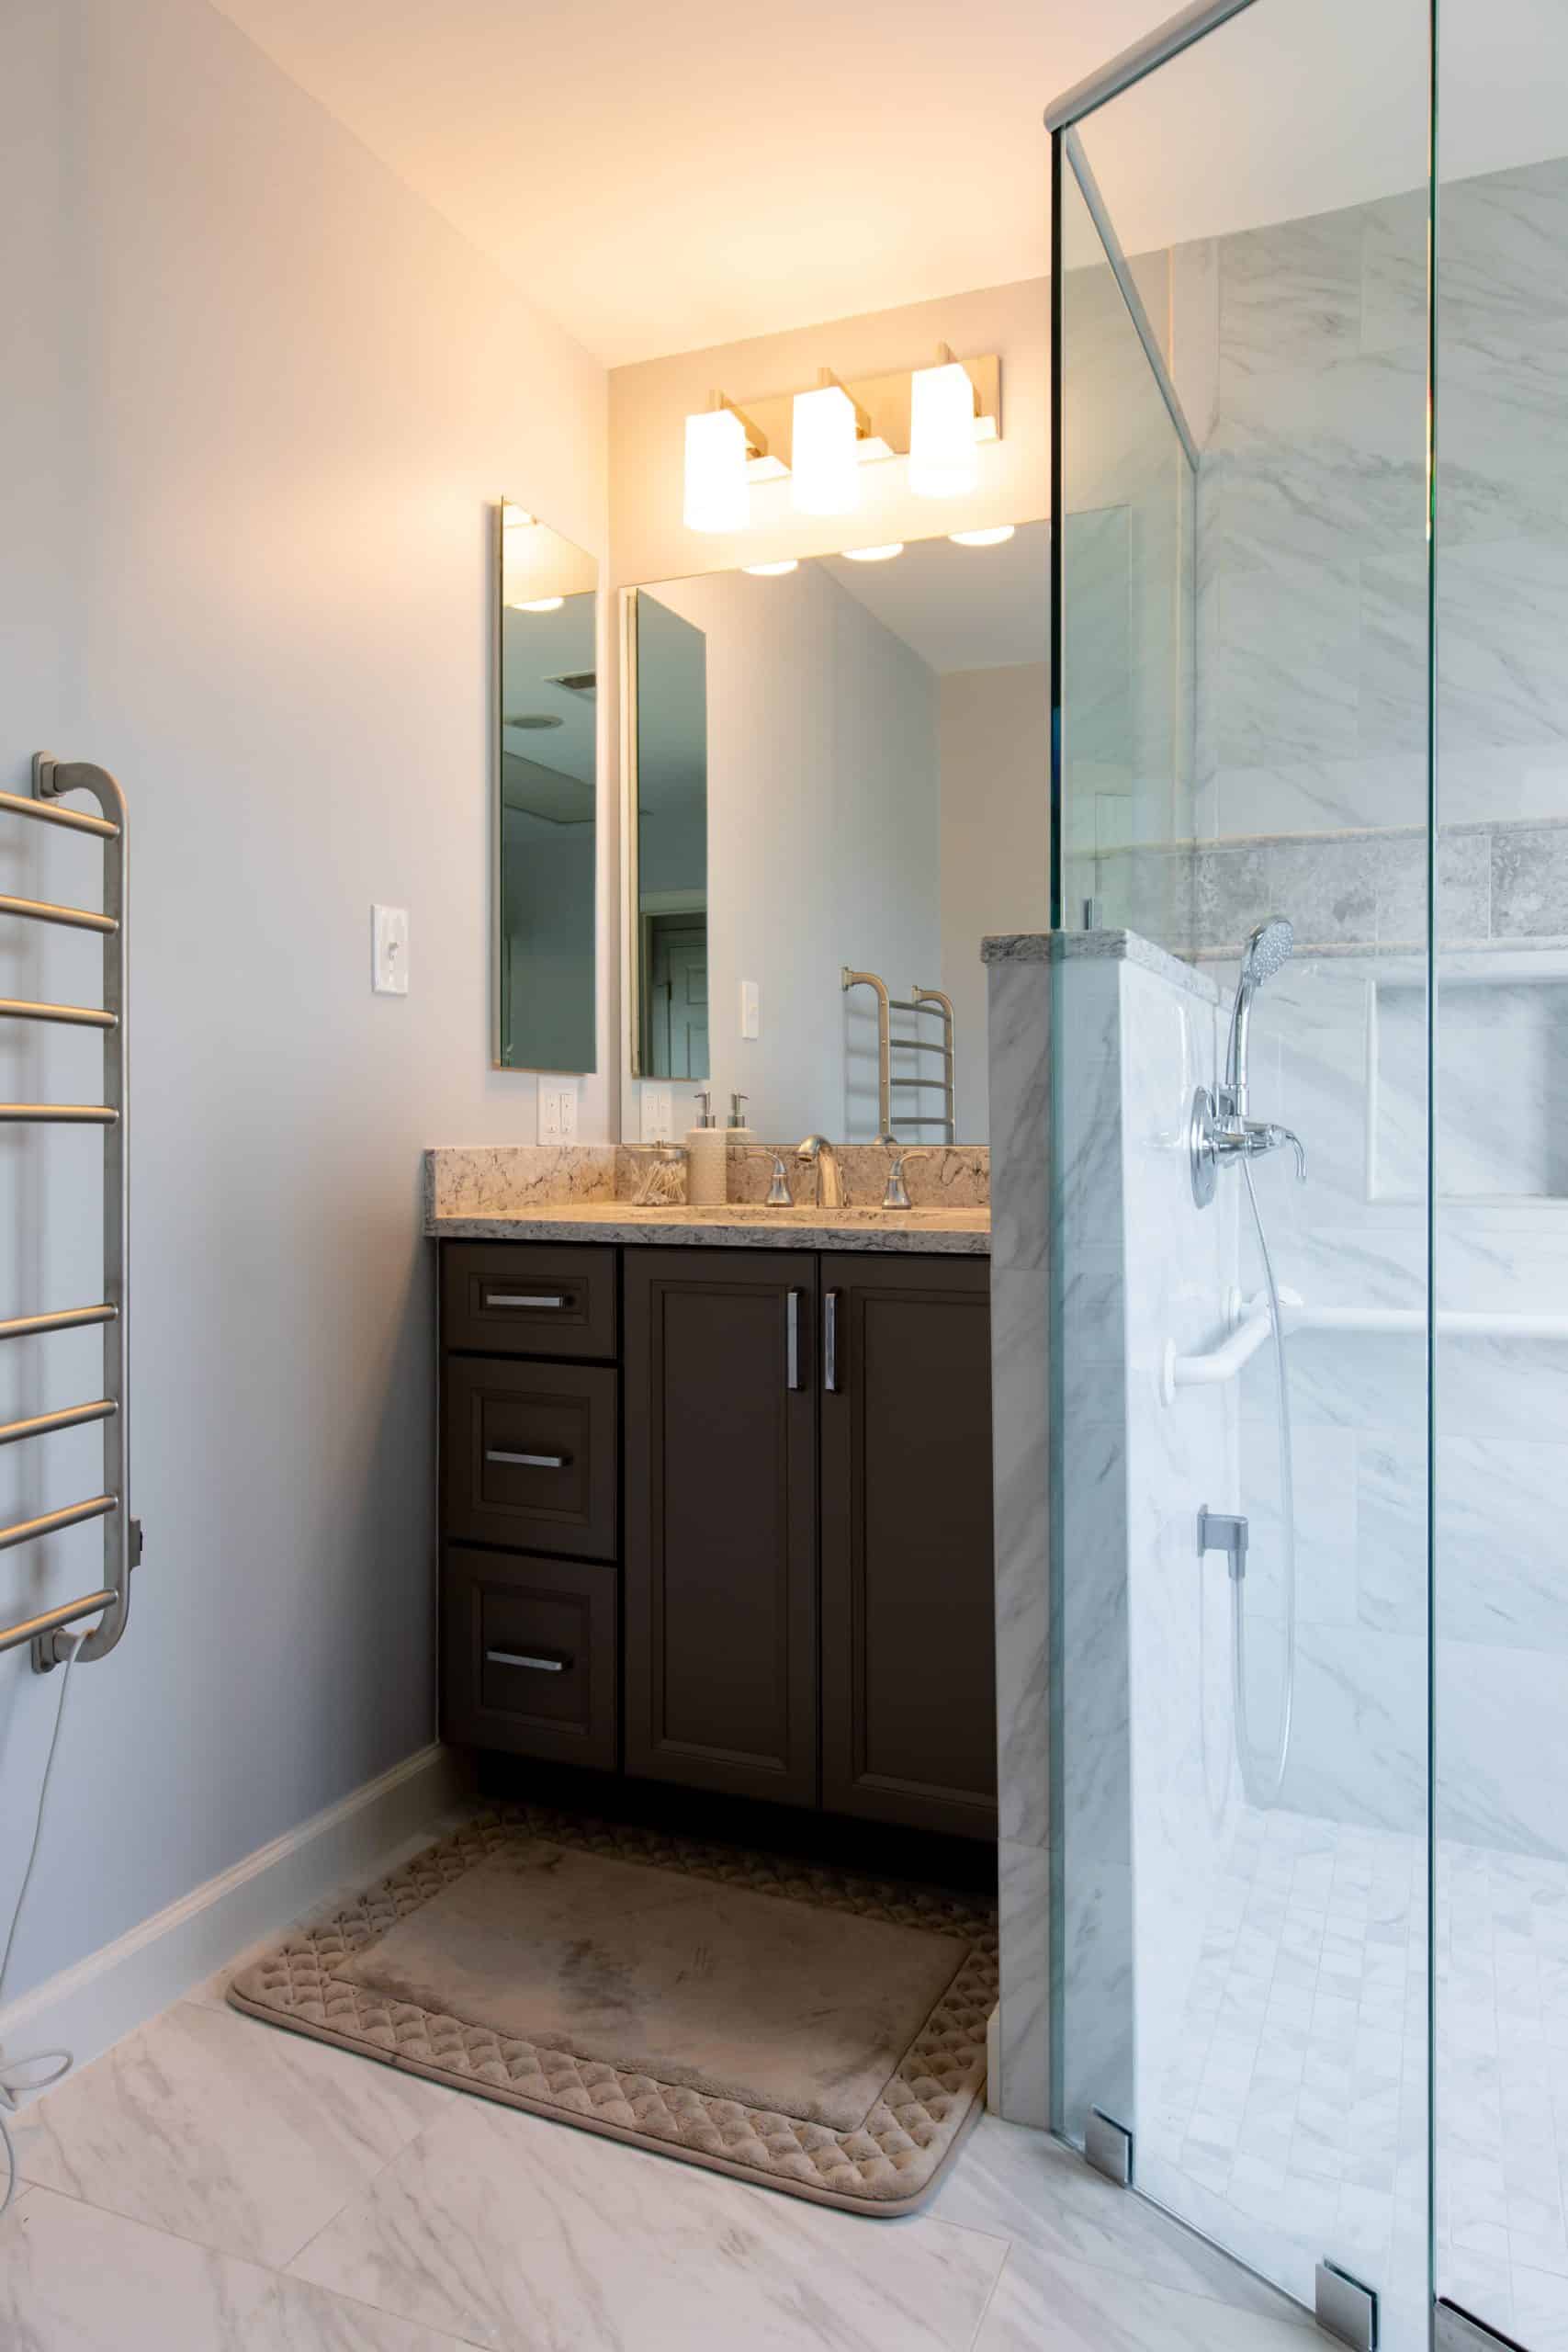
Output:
[{"xmin": 974, "ymin": 2244, "xmax": 1319, "ymax": 2352}]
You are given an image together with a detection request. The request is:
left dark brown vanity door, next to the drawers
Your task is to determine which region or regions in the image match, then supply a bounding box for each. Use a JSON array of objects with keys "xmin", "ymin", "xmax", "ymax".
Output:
[{"xmin": 626, "ymin": 1249, "xmax": 818, "ymax": 1804}]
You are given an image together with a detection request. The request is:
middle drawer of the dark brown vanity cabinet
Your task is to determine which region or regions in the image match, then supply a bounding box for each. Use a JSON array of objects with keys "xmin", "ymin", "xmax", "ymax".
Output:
[{"xmin": 442, "ymin": 1355, "xmax": 621, "ymax": 1559}]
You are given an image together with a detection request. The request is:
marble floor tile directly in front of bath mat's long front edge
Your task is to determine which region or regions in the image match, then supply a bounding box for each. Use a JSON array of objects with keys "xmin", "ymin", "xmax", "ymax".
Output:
[{"xmin": 291, "ymin": 2100, "xmax": 1006, "ymax": 2352}]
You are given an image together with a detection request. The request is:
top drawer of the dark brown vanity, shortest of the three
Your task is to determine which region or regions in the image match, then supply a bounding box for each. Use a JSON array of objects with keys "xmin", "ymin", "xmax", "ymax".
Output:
[{"xmin": 442, "ymin": 1242, "xmax": 616, "ymax": 1362}]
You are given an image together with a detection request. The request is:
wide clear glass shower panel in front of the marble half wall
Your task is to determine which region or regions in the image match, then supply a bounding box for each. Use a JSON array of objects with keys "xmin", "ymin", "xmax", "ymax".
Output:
[{"xmin": 1054, "ymin": 0, "xmax": 1429, "ymax": 2352}]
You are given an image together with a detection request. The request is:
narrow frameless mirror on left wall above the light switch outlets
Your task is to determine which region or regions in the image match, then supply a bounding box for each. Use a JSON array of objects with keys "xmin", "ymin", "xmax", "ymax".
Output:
[{"xmin": 491, "ymin": 503, "xmax": 600, "ymax": 1070}]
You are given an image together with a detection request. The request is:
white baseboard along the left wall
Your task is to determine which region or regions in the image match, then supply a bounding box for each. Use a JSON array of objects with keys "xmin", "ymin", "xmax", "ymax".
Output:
[{"xmin": 0, "ymin": 1743, "xmax": 466, "ymax": 2065}]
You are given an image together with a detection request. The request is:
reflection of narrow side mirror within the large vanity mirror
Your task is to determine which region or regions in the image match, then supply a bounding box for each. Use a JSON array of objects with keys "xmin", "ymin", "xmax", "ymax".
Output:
[{"xmin": 627, "ymin": 588, "xmax": 710, "ymax": 1082}]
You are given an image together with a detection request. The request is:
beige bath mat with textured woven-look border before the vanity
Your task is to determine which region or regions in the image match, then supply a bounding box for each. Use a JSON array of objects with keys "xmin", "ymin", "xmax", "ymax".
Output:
[{"xmin": 228, "ymin": 1806, "xmax": 997, "ymax": 2213}]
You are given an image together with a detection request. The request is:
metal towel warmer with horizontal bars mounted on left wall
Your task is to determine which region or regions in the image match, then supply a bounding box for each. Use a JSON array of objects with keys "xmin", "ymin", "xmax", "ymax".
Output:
[{"xmin": 0, "ymin": 751, "xmax": 141, "ymax": 1675}]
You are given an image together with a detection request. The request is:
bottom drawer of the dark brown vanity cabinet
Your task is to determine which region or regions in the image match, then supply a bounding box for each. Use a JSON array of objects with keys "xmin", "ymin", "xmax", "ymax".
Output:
[{"xmin": 442, "ymin": 1543, "xmax": 618, "ymax": 1771}]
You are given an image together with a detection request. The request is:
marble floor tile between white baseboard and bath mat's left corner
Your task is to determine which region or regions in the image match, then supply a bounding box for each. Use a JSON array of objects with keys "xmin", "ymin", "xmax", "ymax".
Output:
[{"xmin": 17, "ymin": 2002, "xmax": 458, "ymax": 2267}]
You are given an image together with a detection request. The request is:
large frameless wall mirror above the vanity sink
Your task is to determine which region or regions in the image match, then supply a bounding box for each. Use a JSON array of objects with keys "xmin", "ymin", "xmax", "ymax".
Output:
[{"xmin": 627, "ymin": 522, "xmax": 1066, "ymax": 1146}]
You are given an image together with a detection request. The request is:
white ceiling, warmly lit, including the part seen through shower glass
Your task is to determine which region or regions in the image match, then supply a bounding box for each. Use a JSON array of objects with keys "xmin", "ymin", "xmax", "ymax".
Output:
[{"xmin": 219, "ymin": 0, "xmax": 1568, "ymax": 367}]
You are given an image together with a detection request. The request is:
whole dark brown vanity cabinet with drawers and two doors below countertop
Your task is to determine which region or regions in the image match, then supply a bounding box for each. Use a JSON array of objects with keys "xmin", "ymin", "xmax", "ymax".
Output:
[{"xmin": 442, "ymin": 1239, "xmax": 997, "ymax": 1837}]
